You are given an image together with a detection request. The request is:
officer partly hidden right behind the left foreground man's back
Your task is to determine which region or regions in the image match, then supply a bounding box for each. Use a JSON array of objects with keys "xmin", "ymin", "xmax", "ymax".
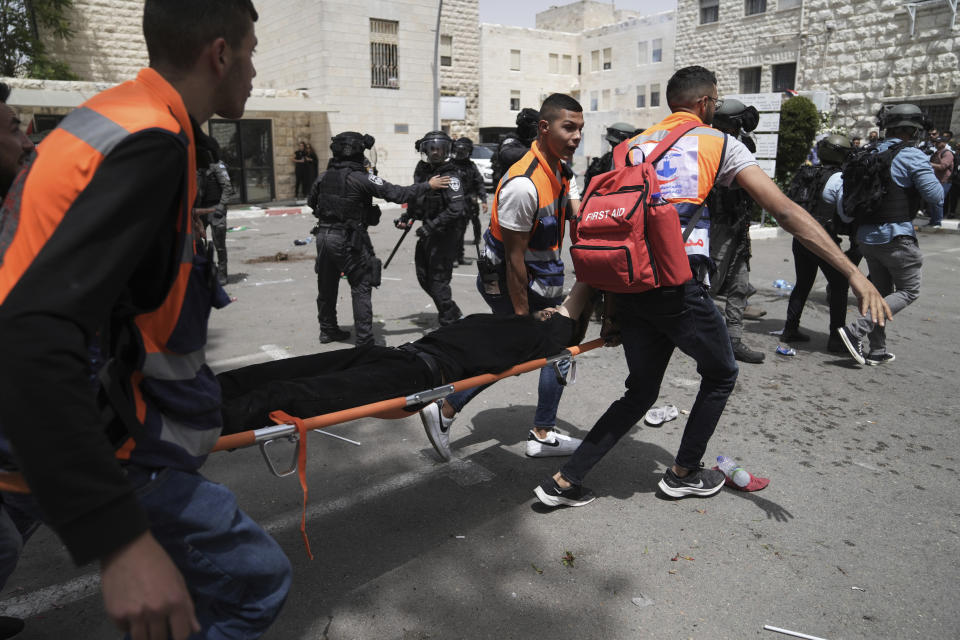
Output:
[{"xmin": 197, "ymin": 133, "xmax": 234, "ymax": 285}]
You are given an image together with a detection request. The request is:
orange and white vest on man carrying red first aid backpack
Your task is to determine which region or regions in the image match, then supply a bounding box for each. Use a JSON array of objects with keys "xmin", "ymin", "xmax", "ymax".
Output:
[{"xmin": 622, "ymin": 111, "xmax": 727, "ymax": 259}]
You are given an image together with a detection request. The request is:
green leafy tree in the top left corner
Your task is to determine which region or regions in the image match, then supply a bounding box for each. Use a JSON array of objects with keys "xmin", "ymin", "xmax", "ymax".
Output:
[{"xmin": 0, "ymin": 0, "xmax": 77, "ymax": 80}]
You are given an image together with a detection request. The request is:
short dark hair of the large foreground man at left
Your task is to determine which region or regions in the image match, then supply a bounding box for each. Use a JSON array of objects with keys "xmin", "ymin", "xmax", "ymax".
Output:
[{"xmin": 143, "ymin": 0, "xmax": 259, "ymax": 70}]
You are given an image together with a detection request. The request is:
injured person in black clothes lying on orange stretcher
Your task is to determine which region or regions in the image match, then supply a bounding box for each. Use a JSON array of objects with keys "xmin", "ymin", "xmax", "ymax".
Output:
[{"xmin": 217, "ymin": 283, "xmax": 593, "ymax": 435}]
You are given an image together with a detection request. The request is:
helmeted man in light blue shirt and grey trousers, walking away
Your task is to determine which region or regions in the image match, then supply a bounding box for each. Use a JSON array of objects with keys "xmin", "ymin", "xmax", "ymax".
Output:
[{"xmin": 836, "ymin": 104, "xmax": 945, "ymax": 366}]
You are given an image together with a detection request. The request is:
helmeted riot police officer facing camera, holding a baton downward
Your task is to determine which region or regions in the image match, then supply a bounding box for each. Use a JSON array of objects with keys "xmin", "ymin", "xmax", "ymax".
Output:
[{"xmin": 396, "ymin": 131, "xmax": 464, "ymax": 326}]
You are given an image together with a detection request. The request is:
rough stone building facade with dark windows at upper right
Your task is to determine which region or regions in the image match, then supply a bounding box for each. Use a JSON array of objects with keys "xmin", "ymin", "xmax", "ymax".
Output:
[{"xmin": 676, "ymin": 0, "xmax": 960, "ymax": 136}]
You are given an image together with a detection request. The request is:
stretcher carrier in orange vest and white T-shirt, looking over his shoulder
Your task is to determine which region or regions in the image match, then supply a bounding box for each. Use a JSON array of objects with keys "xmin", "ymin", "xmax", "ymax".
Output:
[{"xmin": 420, "ymin": 93, "xmax": 583, "ymax": 460}]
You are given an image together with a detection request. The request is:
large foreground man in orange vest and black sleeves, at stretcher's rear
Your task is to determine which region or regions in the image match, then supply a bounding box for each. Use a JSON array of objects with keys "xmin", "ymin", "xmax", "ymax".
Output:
[{"xmin": 0, "ymin": 0, "xmax": 291, "ymax": 640}]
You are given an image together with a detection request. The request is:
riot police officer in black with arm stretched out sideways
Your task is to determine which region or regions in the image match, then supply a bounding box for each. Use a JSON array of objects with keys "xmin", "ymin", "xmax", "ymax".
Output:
[{"xmin": 307, "ymin": 131, "xmax": 450, "ymax": 347}]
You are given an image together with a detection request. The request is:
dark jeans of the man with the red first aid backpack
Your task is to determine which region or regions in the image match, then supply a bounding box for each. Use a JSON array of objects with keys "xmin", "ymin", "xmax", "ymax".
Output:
[{"xmin": 560, "ymin": 280, "xmax": 739, "ymax": 484}]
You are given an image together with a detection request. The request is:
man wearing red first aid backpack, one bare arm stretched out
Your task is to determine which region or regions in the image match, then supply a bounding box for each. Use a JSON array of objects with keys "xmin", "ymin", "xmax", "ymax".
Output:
[{"xmin": 534, "ymin": 66, "xmax": 889, "ymax": 507}]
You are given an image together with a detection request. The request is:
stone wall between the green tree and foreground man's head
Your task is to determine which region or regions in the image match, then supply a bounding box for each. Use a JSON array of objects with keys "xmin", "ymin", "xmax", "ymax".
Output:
[{"xmin": 47, "ymin": 0, "xmax": 147, "ymax": 83}]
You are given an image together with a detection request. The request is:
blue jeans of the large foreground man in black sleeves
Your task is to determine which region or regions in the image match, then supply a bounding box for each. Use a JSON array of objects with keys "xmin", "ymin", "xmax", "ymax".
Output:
[{"xmin": 128, "ymin": 467, "xmax": 291, "ymax": 640}]
